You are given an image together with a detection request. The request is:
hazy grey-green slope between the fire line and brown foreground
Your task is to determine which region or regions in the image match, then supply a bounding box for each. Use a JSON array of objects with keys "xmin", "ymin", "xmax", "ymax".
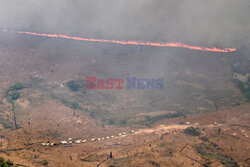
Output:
[{"xmin": 0, "ymin": 32, "xmax": 246, "ymax": 126}]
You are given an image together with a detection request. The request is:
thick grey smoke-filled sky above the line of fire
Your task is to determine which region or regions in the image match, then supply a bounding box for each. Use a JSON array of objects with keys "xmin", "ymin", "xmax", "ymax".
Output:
[{"xmin": 0, "ymin": 0, "xmax": 250, "ymax": 47}]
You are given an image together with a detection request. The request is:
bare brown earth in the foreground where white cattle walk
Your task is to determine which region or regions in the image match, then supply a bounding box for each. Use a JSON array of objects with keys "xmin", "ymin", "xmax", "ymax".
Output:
[{"xmin": 1, "ymin": 103, "xmax": 250, "ymax": 166}]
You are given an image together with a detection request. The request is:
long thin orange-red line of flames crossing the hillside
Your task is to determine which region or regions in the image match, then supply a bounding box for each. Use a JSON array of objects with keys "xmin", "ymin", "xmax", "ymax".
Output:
[{"xmin": 2, "ymin": 30, "xmax": 236, "ymax": 53}]
